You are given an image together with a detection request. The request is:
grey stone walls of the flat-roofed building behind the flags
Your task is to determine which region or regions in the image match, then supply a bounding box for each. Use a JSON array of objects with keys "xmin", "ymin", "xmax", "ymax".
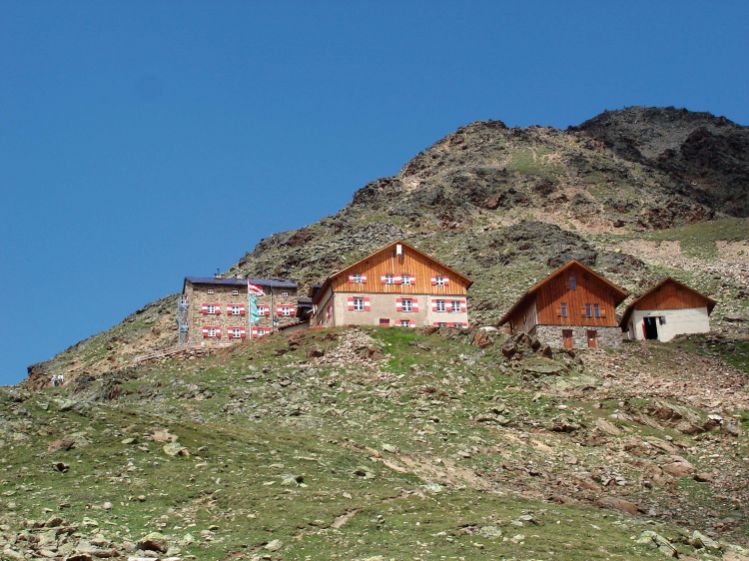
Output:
[{"xmin": 183, "ymin": 282, "xmax": 299, "ymax": 346}]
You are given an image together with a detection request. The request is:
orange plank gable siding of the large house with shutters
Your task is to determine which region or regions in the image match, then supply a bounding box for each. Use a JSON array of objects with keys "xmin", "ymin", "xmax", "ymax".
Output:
[{"xmin": 331, "ymin": 246, "xmax": 468, "ymax": 296}]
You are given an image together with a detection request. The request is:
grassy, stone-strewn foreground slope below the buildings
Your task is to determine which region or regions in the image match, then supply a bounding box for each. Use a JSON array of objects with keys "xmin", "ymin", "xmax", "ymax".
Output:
[{"xmin": 0, "ymin": 327, "xmax": 749, "ymax": 561}]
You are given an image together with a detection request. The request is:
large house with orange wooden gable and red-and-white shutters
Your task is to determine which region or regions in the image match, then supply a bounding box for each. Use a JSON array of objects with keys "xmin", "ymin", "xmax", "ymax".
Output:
[{"xmin": 310, "ymin": 241, "xmax": 472, "ymax": 328}]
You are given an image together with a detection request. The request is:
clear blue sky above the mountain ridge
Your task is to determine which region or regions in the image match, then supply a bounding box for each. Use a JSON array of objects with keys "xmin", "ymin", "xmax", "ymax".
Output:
[{"xmin": 0, "ymin": 0, "xmax": 749, "ymax": 384}]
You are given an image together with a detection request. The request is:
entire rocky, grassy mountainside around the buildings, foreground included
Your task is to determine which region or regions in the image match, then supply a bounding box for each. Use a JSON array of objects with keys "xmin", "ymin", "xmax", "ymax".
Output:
[{"xmin": 8, "ymin": 108, "xmax": 749, "ymax": 561}]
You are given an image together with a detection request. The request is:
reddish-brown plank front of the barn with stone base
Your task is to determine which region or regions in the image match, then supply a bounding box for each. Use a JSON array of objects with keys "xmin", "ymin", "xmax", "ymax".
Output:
[{"xmin": 536, "ymin": 266, "xmax": 617, "ymax": 327}]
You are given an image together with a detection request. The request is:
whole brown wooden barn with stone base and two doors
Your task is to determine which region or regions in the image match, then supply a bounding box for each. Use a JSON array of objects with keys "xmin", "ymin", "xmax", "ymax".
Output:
[{"xmin": 500, "ymin": 260, "xmax": 627, "ymax": 349}]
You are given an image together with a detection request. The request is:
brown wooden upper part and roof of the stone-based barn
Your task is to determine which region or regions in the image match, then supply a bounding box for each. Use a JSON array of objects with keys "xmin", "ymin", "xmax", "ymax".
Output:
[{"xmin": 500, "ymin": 260, "xmax": 627, "ymax": 327}]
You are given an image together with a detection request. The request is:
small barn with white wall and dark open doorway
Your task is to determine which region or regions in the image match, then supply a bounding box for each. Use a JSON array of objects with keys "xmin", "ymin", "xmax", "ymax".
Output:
[{"xmin": 619, "ymin": 277, "xmax": 716, "ymax": 341}]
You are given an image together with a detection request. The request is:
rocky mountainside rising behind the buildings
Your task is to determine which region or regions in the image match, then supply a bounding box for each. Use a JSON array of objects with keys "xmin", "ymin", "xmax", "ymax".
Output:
[{"xmin": 30, "ymin": 108, "xmax": 749, "ymax": 381}]
